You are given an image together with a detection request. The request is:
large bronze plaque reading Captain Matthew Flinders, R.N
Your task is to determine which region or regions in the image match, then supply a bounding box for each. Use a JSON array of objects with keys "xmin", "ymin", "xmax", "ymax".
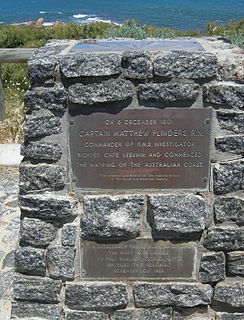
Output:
[{"xmin": 69, "ymin": 108, "xmax": 211, "ymax": 190}]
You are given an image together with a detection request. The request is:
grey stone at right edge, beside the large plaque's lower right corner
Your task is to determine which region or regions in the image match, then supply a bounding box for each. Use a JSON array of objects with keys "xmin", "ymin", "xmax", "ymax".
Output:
[{"xmin": 213, "ymin": 161, "xmax": 244, "ymax": 194}]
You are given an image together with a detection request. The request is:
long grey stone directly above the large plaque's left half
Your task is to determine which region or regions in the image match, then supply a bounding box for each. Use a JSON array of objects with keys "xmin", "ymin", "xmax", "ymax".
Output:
[{"xmin": 69, "ymin": 79, "xmax": 134, "ymax": 105}]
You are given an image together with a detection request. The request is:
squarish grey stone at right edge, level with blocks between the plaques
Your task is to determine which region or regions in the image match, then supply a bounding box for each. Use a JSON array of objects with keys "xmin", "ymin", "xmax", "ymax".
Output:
[{"xmin": 214, "ymin": 196, "xmax": 244, "ymax": 225}]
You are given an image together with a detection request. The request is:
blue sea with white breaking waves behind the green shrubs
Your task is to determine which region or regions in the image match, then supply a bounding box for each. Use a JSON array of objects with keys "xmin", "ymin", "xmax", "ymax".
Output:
[{"xmin": 0, "ymin": 0, "xmax": 244, "ymax": 30}]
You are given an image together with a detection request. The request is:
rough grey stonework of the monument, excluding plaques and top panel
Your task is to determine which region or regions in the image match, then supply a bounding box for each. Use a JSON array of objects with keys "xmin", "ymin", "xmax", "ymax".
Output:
[{"xmin": 12, "ymin": 39, "xmax": 244, "ymax": 320}]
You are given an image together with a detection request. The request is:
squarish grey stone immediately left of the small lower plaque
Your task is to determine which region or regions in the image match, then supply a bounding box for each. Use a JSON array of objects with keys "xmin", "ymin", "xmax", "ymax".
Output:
[{"xmin": 47, "ymin": 246, "xmax": 75, "ymax": 280}]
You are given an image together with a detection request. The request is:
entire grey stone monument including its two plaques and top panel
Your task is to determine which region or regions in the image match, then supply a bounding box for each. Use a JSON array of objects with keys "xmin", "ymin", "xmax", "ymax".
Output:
[{"xmin": 12, "ymin": 38, "xmax": 244, "ymax": 320}]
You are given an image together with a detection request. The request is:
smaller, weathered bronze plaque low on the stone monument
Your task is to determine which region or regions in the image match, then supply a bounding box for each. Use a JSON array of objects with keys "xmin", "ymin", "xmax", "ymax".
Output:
[{"xmin": 81, "ymin": 239, "xmax": 196, "ymax": 279}]
